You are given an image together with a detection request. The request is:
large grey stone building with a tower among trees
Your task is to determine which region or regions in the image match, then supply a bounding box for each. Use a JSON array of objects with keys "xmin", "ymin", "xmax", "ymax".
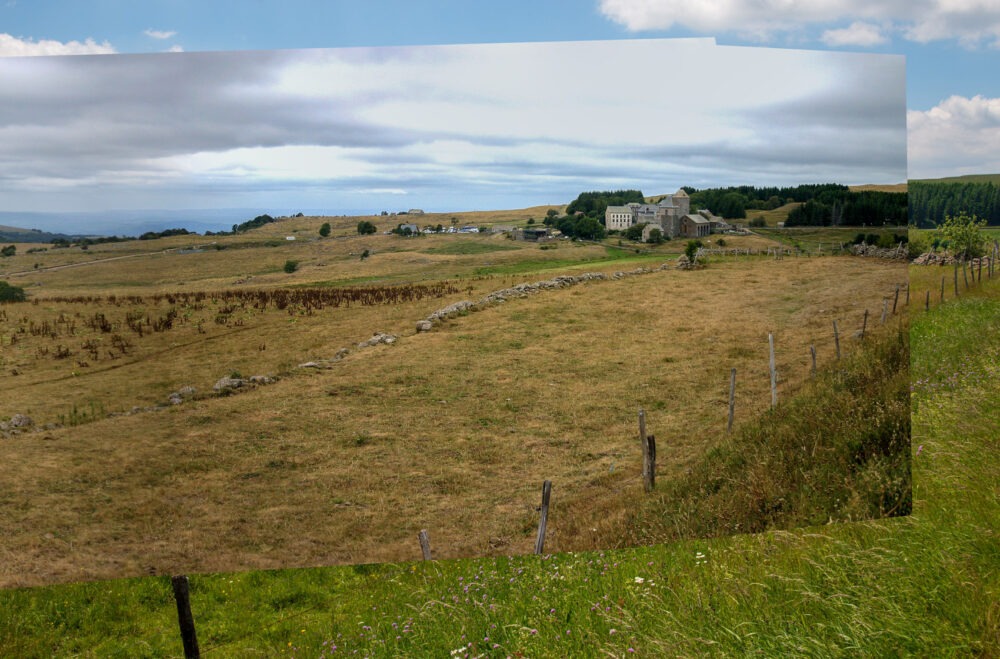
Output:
[{"xmin": 604, "ymin": 189, "xmax": 729, "ymax": 240}]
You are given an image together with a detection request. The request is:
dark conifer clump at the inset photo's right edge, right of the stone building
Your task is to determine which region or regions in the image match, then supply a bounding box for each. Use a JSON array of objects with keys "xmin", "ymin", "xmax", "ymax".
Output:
[{"xmin": 785, "ymin": 190, "xmax": 908, "ymax": 227}]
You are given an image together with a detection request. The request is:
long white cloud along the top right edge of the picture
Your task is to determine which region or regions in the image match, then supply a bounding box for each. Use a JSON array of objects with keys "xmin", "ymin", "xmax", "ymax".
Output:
[{"xmin": 600, "ymin": 0, "xmax": 1000, "ymax": 47}]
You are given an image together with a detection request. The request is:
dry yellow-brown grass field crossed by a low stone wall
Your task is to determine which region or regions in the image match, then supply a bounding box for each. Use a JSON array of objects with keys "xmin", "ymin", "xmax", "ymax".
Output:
[{"xmin": 0, "ymin": 215, "xmax": 907, "ymax": 587}]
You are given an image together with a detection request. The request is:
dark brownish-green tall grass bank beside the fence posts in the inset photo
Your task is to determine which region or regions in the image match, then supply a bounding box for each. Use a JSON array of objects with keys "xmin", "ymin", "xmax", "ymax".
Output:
[{"xmin": 628, "ymin": 328, "xmax": 912, "ymax": 544}]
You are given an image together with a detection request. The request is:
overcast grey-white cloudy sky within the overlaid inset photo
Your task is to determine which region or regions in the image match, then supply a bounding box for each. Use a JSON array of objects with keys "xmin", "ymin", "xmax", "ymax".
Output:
[{"xmin": 0, "ymin": 39, "xmax": 906, "ymax": 227}]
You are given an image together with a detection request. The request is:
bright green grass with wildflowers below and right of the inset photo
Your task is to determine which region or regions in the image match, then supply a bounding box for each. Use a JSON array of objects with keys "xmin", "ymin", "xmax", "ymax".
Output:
[{"xmin": 0, "ymin": 284, "xmax": 1000, "ymax": 657}]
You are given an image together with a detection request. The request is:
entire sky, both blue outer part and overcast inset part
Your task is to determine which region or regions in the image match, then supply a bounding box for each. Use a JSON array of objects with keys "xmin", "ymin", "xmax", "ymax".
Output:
[{"xmin": 0, "ymin": 0, "xmax": 1000, "ymax": 235}]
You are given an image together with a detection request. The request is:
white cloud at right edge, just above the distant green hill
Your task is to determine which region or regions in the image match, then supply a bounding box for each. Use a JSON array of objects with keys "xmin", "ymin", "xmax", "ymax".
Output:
[{"xmin": 907, "ymin": 96, "xmax": 1000, "ymax": 178}]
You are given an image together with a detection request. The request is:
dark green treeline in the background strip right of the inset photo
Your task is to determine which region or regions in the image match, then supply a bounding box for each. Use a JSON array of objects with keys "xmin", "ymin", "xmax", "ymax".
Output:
[{"xmin": 908, "ymin": 181, "xmax": 1000, "ymax": 228}]
